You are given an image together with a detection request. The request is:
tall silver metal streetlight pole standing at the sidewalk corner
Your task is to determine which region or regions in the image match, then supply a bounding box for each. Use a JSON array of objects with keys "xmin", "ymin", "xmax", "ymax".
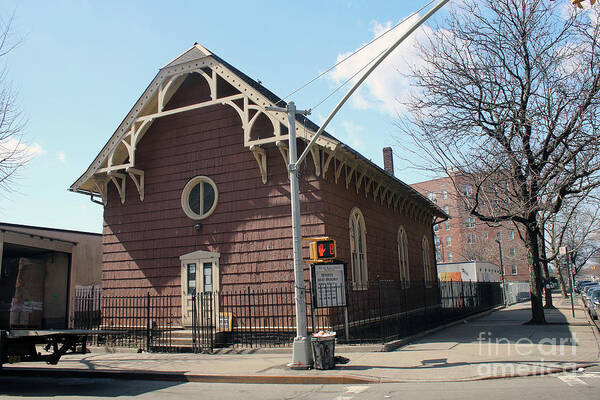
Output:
[{"xmin": 266, "ymin": 101, "xmax": 313, "ymax": 369}]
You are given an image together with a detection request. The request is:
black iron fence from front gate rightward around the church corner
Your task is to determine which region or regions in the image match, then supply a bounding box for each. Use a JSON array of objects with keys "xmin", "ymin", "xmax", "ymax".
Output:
[{"xmin": 193, "ymin": 280, "xmax": 502, "ymax": 349}]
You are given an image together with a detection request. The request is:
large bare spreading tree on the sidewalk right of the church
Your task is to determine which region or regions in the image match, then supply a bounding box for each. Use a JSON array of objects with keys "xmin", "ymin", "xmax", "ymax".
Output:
[{"xmin": 399, "ymin": 0, "xmax": 600, "ymax": 323}]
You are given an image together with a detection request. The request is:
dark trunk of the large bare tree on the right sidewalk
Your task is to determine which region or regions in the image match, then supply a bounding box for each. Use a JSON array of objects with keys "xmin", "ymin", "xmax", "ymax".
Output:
[{"xmin": 525, "ymin": 223, "xmax": 546, "ymax": 325}]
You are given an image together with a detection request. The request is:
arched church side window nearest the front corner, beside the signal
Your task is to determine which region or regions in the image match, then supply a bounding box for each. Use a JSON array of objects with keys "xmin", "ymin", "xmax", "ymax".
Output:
[{"xmin": 350, "ymin": 207, "xmax": 369, "ymax": 290}]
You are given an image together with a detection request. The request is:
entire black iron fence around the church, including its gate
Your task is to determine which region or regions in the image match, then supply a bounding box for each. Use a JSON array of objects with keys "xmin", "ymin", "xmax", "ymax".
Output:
[{"xmin": 74, "ymin": 280, "xmax": 502, "ymax": 352}]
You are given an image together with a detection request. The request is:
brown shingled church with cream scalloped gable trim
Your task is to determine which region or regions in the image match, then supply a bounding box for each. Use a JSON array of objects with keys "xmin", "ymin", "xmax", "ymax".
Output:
[{"xmin": 70, "ymin": 44, "xmax": 446, "ymax": 324}]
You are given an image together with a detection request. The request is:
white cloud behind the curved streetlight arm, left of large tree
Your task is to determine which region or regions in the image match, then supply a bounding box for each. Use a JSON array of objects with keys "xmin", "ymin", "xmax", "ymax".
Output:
[{"xmin": 330, "ymin": 15, "xmax": 431, "ymax": 115}]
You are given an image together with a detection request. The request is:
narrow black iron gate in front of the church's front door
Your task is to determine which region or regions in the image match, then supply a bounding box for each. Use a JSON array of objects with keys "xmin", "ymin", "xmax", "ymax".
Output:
[{"xmin": 192, "ymin": 292, "xmax": 216, "ymax": 353}]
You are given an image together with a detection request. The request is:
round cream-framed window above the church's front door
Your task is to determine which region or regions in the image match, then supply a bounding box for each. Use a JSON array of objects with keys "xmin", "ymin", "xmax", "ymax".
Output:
[{"xmin": 181, "ymin": 176, "xmax": 219, "ymax": 220}]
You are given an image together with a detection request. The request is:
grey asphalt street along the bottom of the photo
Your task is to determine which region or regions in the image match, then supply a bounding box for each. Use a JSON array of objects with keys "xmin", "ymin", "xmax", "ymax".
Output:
[{"xmin": 0, "ymin": 368, "xmax": 600, "ymax": 400}]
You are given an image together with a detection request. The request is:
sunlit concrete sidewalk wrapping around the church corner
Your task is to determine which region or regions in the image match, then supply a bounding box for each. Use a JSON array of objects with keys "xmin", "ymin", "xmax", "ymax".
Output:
[{"xmin": 3, "ymin": 296, "xmax": 600, "ymax": 384}]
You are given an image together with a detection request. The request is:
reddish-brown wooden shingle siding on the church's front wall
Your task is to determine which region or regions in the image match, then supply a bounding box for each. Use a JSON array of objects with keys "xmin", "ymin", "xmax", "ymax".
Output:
[{"xmin": 103, "ymin": 76, "xmax": 324, "ymax": 298}]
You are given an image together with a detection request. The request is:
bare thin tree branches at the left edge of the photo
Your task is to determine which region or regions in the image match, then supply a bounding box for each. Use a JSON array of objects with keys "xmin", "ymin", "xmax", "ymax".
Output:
[{"xmin": 0, "ymin": 12, "xmax": 30, "ymax": 193}]
